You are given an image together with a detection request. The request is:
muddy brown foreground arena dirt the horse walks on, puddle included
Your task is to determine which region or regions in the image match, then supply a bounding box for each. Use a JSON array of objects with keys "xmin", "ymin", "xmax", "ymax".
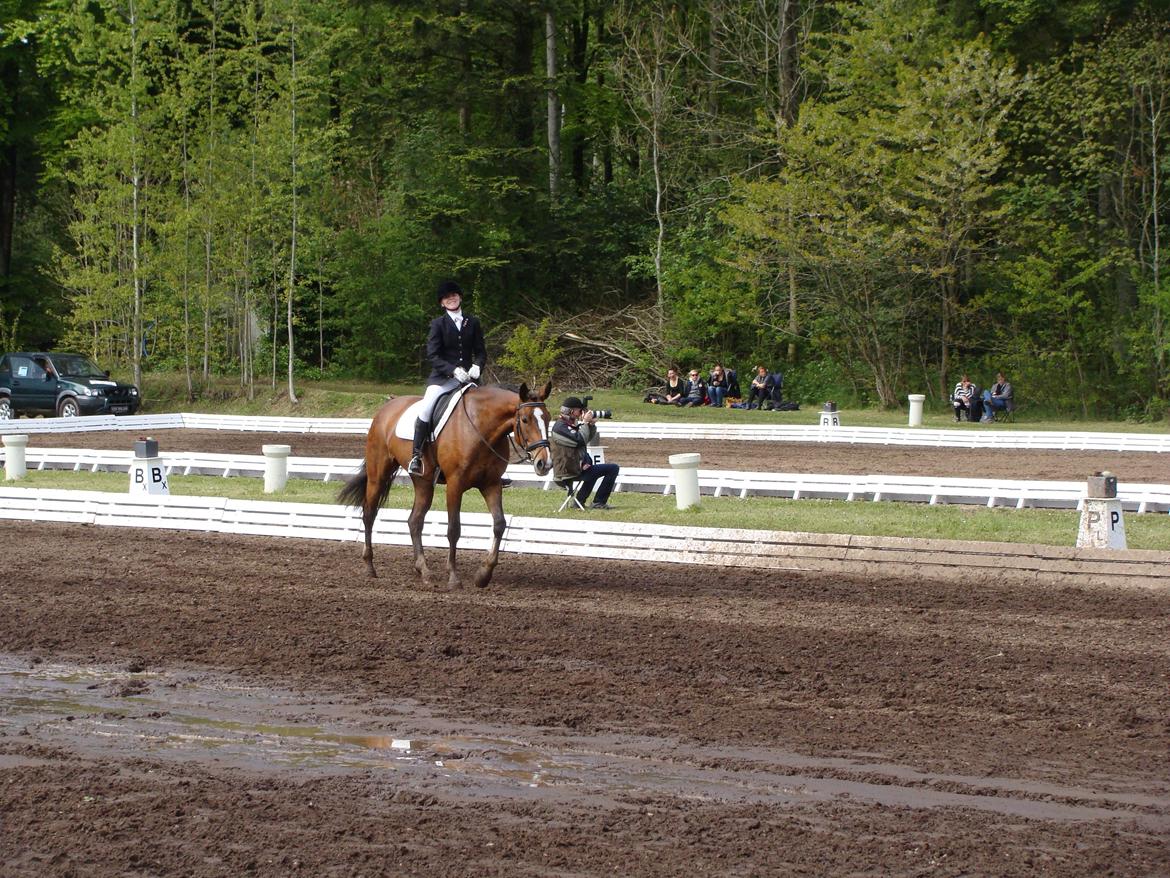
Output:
[{"xmin": 0, "ymin": 519, "xmax": 1170, "ymax": 878}]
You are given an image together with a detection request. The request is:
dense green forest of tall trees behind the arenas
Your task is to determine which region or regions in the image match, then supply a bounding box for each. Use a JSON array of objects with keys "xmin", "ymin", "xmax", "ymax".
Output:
[{"xmin": 0, "ymin": 0, "xmax": 1170, "ymax": 420}]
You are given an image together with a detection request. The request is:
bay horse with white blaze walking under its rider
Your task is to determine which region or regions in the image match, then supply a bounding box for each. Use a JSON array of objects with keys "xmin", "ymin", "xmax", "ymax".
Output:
[{"xmin": 338, "ymin": 380, "xmax": 552, "ymax": 588}]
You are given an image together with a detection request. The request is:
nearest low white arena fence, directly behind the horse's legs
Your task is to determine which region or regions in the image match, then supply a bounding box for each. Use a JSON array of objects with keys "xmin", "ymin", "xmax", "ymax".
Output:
[{"xmin": 0, "ymin": 486, "xmax": 1170, "ymax": 589}]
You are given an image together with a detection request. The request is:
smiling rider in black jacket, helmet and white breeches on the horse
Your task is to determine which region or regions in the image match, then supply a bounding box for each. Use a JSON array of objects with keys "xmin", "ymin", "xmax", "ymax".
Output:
[{"xmin": 406, "ymin": 281, "xmax": 488, "ymax": 475}]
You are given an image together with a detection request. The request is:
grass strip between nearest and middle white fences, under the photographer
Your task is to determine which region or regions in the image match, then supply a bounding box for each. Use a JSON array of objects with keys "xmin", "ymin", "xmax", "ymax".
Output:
[{"xmin": 7, "ymin": 471, "xmax": 1170, "ymax": 551}]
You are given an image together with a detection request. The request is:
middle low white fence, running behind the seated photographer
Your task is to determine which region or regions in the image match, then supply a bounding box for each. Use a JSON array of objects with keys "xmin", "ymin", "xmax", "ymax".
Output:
[{"xmin": 0, "ymin": 447, "xmax": 1170, "ymax": 513}]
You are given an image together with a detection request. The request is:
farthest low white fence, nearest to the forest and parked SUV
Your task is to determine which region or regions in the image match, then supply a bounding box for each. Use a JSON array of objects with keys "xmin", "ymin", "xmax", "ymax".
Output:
[{"xmin": 0, "ymin": 412, "xmax": 1170, "ymax": 453}]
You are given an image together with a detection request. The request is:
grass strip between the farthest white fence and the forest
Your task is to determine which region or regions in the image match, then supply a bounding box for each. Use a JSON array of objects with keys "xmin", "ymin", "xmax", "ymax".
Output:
[{"xmin": 123, "ymin": 372, "xmax": 1166, "ymax": 433}]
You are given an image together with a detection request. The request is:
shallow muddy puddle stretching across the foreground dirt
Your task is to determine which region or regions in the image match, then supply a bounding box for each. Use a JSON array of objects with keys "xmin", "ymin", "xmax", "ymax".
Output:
[{"xmin": 0, "ymin": 654, "xmax": 1170, "ymax": 830}]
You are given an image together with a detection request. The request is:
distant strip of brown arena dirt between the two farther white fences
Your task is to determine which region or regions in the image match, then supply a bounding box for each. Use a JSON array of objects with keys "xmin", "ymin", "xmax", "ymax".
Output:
[{"xmin": 16, "ymin": 424, "xmax": 1170, "ymax": 483}]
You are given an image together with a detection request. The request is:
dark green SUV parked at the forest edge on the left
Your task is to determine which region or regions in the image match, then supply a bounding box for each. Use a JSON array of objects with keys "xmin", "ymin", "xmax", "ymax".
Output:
[{"xmin": 0, "ymin": 352, "xmax": 138, "ymax": 420}]
